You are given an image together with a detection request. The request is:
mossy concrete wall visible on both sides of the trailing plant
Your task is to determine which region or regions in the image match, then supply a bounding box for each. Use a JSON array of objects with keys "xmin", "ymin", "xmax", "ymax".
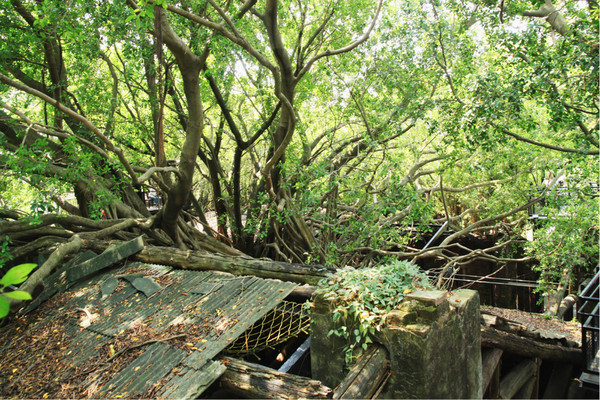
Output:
[{"xmin": 311, "ymin": 290, "xmax": 482, "ymax": 398}]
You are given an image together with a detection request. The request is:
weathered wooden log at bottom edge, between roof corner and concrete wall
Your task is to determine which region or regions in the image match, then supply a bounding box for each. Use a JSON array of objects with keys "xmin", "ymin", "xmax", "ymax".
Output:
[{"xmin": 219, "ymin": 357, "xmax": 331, "ymax": 399}]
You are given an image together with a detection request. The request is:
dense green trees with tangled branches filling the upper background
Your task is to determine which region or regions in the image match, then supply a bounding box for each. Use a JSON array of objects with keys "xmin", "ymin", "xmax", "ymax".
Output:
[{"xmin": 0, "ymin": 0, "xmax": 599, "ymax": 316}]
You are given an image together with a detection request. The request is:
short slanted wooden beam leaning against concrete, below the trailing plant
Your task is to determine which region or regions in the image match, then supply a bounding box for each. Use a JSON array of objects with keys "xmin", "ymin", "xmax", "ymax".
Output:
[{"xmin": 333, "ymin": 344, "xmax": 389, "ymax": 399}]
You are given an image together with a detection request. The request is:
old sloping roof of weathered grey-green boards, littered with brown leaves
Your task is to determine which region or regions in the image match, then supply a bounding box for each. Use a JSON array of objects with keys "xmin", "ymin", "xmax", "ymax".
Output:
[{"xmin": 0, "ymin": 239, "xmax": 296, "ymax": 398}]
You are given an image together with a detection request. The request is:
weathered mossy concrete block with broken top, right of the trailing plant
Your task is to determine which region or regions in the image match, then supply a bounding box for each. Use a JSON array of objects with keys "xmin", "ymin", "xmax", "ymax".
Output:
[{"xmin": 379, "ymin": 290, "xmax": 482, "ymax": 399}]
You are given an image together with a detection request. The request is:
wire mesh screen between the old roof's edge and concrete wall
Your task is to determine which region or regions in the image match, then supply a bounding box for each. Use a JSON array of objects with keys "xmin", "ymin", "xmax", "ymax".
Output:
[{"xmin": 225, "ymin": 301, "xmax": 310, "ymax": 355}]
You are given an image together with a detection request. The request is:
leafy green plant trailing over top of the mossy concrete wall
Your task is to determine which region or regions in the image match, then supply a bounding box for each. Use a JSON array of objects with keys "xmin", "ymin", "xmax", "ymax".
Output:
[{"xmin": 319, "ymin": 260, "xmax": 432, "ymax": 365}]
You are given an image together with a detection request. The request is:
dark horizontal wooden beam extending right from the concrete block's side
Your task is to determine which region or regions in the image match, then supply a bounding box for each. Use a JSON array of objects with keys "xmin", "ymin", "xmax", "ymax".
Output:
[{"xmin": 481, "ymin": 326, "xmax": 583, "ymax": 365}]
